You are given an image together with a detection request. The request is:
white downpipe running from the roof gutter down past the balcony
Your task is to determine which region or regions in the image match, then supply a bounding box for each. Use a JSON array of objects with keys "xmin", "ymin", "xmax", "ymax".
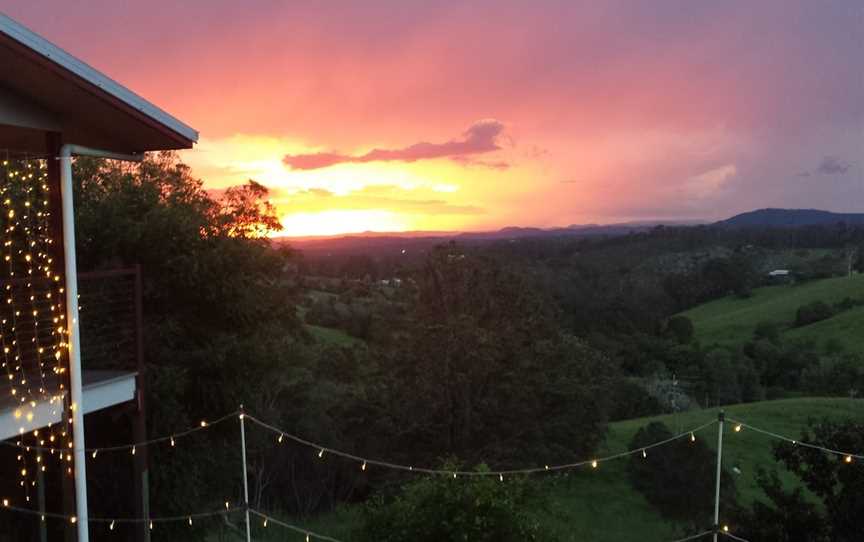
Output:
[{"xmin": 58, "ymin": 143, "xmax": 141, "ymax": 542}]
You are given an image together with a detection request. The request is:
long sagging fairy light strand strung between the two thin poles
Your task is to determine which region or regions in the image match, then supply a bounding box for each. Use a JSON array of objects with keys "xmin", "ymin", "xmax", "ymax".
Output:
[{"xmin": 246, "ymin": 413, "xmax": 717, "ymax": 478}]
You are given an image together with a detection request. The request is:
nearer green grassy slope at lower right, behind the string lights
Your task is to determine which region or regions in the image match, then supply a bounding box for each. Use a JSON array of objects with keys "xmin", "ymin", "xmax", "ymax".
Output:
[{"xmin": 253, "ymin": 398, "xmax": 864, "ymax": 542}]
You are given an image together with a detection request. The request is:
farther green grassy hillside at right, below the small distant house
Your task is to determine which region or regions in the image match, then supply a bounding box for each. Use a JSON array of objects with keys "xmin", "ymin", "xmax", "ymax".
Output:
[{"xmin": 682, "ymin": 274, "xmax": 864, "ymax": 350}]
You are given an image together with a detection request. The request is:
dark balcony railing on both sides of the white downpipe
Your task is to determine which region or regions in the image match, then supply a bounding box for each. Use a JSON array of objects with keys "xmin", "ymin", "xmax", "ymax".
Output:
[{"xmin": 0, "ymin": 266, "xmax": 143, "ymax": 424}]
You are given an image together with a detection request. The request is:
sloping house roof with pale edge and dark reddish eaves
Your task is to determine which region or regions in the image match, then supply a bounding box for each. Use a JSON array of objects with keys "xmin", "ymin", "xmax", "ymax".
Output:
[{"xmin": 0, "ymin": 13, "xmax": 198, "ymax": 153}]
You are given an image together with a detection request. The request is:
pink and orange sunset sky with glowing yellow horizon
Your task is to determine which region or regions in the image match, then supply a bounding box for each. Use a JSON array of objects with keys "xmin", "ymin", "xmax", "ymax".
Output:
[{"xmin": 0, "ymin": 0, "xmax": 864, "ymax": 235}]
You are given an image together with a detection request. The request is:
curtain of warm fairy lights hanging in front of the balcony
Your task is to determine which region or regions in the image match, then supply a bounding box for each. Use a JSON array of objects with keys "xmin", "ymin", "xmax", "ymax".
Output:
[{"xmin": 0, "ymin": 157, "xmax": 72, "ymax": 503}]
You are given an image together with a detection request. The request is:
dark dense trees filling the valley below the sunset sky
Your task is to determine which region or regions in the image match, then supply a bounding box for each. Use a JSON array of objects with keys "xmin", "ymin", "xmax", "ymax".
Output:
[{"xmin": 1, "ymin": 153, "xmax": 864, "ymax": 540}]
